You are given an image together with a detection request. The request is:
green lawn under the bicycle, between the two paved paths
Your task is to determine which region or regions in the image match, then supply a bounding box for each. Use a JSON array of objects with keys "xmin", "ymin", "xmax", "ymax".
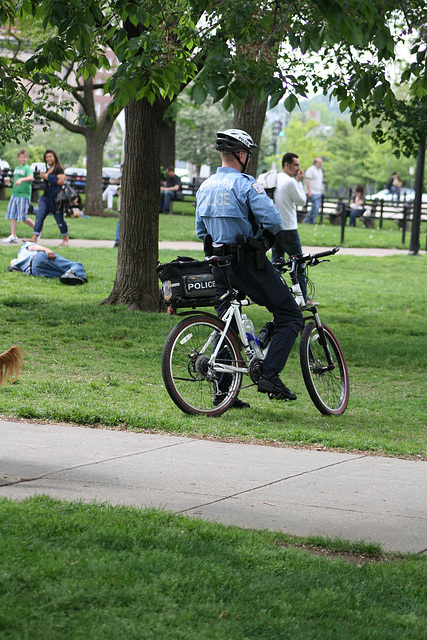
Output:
[{"xmin": 0, "ymin": 246, "xmax": 427, "ymax": 456}]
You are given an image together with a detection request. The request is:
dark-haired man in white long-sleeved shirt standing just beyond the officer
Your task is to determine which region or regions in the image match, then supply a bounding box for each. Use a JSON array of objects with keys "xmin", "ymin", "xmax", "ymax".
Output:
[{"xmin": 272, "ymin": 153, "xmax": 306, "ymax": 298}]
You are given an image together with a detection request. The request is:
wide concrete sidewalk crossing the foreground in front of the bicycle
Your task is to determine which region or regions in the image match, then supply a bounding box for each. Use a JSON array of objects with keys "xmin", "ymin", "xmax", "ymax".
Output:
[{"xmin": 0, "ymin": 421, "xmax": 427, "ymax": 553}]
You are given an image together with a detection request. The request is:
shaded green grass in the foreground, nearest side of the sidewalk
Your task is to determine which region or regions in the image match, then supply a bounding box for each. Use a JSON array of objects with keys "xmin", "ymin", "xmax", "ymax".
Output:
[{"xmin": 0, "ymin": 496, "xmax": 427, "ymax": 640}]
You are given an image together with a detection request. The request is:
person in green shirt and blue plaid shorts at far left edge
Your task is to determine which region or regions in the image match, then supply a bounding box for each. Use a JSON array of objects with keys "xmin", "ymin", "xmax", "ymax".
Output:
[{"xmin": 3, "ymin": 149, "xmax": 34, "ymax": 244}]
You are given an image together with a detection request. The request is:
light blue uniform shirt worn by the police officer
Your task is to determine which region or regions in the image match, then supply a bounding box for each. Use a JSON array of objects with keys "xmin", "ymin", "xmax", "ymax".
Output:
[{"xmin": 196, "ymin": 167, "xmax": 283, "ymax": 244}]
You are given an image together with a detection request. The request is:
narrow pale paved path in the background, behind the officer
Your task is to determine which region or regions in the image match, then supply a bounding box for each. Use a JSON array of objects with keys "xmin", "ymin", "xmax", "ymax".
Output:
[{"xmin": 30, "ymin": 238, "xmax": 414, "ymax": 257}]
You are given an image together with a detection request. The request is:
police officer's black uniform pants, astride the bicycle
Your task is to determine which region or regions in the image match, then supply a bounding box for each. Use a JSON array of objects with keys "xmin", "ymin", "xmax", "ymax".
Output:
[{"xmin": 213, "ymin": 253, "xmax": 302, "ymax": 378}]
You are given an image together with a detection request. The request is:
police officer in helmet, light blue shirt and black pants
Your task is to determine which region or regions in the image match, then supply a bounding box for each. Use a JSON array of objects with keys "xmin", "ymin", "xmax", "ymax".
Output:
[{"xmin": 196, "ymin": 129, "xmax": 302, "ymax": 400}]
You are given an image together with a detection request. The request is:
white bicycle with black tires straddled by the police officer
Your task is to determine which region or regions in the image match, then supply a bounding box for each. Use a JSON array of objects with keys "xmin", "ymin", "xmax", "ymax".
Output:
[{"xmin": 162, "ymin": 247, "xmax": 349, "ymax": 417}]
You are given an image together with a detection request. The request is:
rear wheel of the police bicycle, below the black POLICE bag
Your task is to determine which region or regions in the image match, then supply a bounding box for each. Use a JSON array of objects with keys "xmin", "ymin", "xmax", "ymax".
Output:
[{"xmin": 162, "ymin": 316, "xmax": 243, "ymax": 416}]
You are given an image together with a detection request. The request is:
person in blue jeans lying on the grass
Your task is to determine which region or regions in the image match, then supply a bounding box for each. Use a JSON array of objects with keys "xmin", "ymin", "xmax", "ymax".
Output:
[{"xmin": 8, "ymin": 242, "xmax": 87, "ymax": 285}]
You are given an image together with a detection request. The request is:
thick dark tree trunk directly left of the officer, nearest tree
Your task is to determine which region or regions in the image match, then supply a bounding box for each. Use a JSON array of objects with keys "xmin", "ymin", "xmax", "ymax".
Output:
[{"xmin": 102, "ymin": 99, "xmax": 168, "ymax": 311}]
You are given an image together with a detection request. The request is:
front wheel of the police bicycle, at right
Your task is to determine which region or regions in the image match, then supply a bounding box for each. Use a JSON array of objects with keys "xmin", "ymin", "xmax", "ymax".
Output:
[{"xmin": 300, "ymin": 322, "xmax": 350, "ymax": 416}]
